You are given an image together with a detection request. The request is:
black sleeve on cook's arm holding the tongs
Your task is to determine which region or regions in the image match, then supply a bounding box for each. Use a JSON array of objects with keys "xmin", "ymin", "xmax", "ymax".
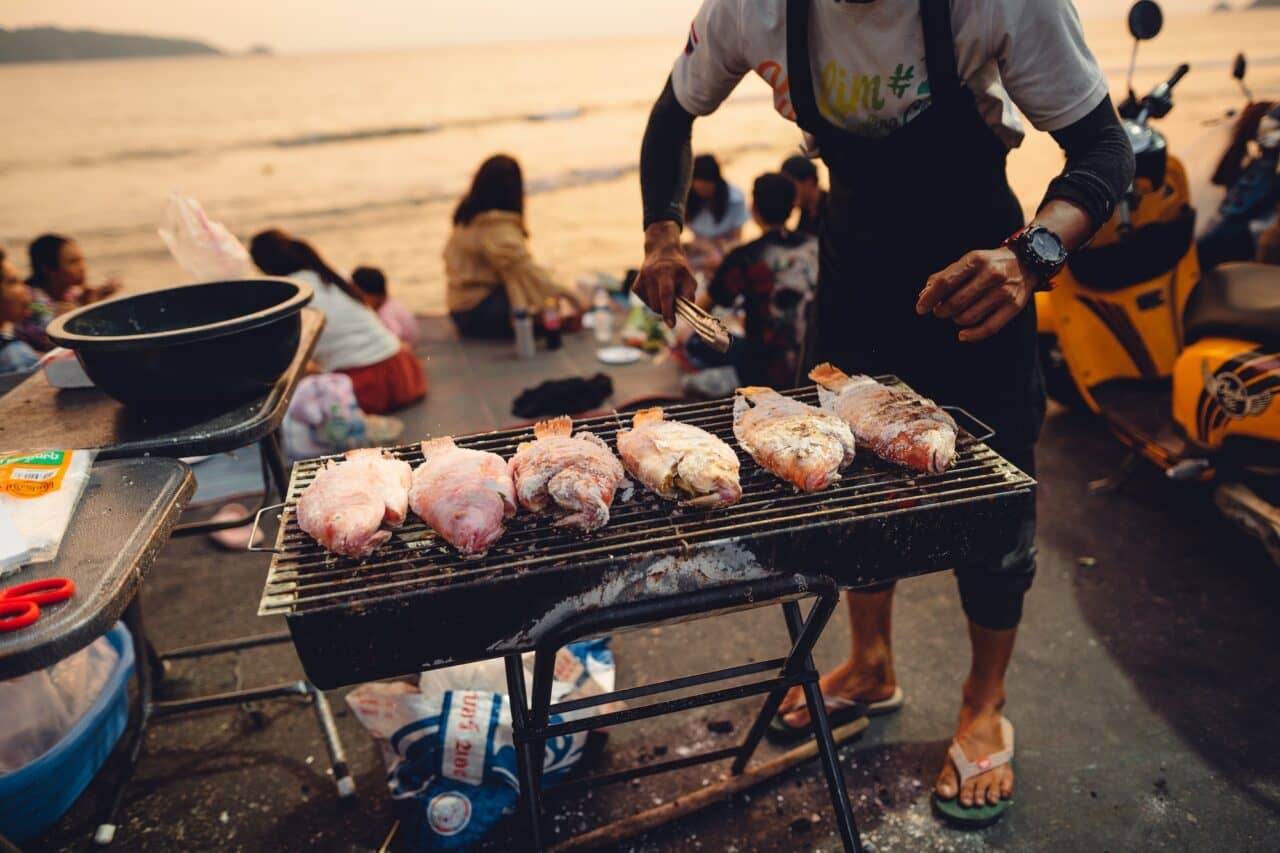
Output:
[{"xmin": 640, "ymin": 77, "xmax": 694, "ymax": 228}]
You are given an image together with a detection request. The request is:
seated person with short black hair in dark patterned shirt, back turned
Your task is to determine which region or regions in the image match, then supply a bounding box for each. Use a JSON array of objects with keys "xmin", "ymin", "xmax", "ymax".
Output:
[{"xmin": 687, "ymin": 173, "xmax": 818, "ymax": 388}]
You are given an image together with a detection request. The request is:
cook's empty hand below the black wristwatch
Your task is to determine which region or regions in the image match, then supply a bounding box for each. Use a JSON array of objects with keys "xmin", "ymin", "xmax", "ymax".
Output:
[{"xmin": 915, "ymin": 247, "xmax": 1037, "ymax": 342}]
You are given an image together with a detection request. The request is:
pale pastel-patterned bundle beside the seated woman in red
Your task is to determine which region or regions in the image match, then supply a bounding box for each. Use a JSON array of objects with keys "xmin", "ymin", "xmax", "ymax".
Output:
[{"xmin": 282, "ymin": 373, "xmax": 369, "ymax": 460}]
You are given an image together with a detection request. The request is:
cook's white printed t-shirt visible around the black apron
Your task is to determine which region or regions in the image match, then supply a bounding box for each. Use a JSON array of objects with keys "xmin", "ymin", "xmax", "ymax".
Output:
[{"xmin": 672, "ymin": 0, "xmax": 1107, "ymax": 147}]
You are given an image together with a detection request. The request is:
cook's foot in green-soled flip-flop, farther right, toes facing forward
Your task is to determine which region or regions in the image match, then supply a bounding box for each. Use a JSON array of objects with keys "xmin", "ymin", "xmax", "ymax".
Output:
[{"xmin": 933, "ymin": 706, "xmax": 1014, "ymax": 827}]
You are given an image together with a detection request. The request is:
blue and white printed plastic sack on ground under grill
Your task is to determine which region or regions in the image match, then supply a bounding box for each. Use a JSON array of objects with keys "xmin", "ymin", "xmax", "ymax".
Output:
[{"xmin": 347, "ymin": 639, "xmax": 614, "ymax": 850}]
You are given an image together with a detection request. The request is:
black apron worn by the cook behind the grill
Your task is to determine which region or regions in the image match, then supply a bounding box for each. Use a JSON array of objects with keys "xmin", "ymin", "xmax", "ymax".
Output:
[{"xmin": 787, "ymin": 0, "xmax": 1044, "ymax": 450}]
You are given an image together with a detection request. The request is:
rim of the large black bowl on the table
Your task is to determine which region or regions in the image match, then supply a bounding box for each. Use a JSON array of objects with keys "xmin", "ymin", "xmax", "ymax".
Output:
[{"xmin": 45, "ymin": 275, "xmax": 315, "ymax": 352}]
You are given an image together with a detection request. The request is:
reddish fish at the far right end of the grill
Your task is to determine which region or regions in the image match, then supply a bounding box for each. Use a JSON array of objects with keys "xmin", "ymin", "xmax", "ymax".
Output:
[{"xmin": 809, "ymin": 364, "xmax": 956, "ymax": 474}]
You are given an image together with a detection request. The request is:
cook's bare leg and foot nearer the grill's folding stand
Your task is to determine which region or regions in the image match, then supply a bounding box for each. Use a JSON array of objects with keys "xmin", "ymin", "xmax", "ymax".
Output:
[{"xmin": 780, "ymin": 584, "xmax": 897, "ymax": 727}]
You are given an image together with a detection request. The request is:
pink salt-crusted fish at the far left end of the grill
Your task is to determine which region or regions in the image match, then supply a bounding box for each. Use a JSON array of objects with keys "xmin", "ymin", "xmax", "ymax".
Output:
[{"xmin": 297, "ymin": 448, "xmax": 413, "ymax": 557}]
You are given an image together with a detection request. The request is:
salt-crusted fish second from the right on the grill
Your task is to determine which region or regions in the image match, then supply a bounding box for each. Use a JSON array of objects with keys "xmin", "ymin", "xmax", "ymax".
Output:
[{"xmin": 733, "ymin": 388, "xmax": 854, "ymax": 492}]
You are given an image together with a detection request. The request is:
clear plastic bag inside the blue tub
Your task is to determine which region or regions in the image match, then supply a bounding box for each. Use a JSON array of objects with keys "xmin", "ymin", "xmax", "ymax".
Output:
[{"xmin": 0, "ymin": 637, "xmax": 120, "ymax": 775}]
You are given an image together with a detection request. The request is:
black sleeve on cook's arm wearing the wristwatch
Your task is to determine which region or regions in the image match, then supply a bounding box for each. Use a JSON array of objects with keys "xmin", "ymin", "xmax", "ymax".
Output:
[{"xmin": 1041, "ymin": 97, "xmax": 1134, "ymax": 231}]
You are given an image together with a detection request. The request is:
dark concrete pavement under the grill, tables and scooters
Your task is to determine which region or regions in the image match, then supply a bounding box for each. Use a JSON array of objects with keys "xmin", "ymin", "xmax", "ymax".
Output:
[{"xmin": 29, "ymin": 320, "xmax": 1280, "ymax": 853}]
